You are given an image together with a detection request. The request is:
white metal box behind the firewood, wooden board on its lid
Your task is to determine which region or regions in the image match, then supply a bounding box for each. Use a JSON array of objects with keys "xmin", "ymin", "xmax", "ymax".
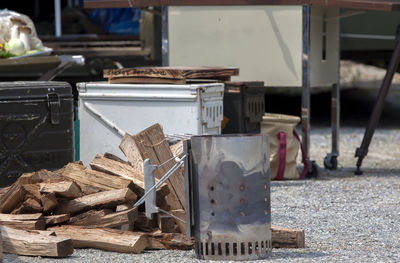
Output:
[{"xmin": 77, "ymin": 82, "xmax": 224, "ymax": 164}]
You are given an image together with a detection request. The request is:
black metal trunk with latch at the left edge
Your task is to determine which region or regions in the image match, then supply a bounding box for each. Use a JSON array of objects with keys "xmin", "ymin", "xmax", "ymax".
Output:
[{"xmin": 0, "ymin": 81, "xmax": 74, "ymax": 187}]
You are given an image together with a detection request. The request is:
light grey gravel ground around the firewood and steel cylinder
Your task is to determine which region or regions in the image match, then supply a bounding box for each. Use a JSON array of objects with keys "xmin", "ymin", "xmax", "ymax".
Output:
[{"xmin": 4, "ymin": 128, "xmax": 400, "ymax": 263}]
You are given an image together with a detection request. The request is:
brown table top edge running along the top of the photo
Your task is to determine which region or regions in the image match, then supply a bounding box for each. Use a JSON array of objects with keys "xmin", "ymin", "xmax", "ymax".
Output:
[{"xmin": 84, "ymin": 0, "xmax": 400, "ymax": 11}]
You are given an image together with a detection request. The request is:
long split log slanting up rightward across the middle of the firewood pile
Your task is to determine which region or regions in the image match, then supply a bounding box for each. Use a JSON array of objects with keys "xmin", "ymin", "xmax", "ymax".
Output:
[{"xmin": 54, "ymin": 188, "xmax": 137, "ymax": 214}]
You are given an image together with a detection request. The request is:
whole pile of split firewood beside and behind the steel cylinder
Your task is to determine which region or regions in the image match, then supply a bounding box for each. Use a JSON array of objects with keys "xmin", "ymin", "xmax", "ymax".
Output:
[{"xmin": 0, "ymin": 124, "xmax": 304, "ymax": 259}]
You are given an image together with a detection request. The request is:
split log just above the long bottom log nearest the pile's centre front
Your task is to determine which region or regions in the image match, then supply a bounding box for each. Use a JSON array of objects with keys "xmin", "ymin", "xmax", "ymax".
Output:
[{"xmin": 69, "ymin": 207, "xmax": 138, "ymax": 228}]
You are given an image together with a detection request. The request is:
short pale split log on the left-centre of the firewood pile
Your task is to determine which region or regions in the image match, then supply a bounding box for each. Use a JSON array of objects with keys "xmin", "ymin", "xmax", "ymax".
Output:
[{"xmin": 39, "ymin": 181, "xmax": 82, "ymax": 198}]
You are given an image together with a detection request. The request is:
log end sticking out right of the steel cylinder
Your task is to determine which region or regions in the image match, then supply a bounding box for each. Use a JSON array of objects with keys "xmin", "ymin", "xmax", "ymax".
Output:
[{"xmin": 271, "ymin": 226, "xmax": 305, "ymax": 248}]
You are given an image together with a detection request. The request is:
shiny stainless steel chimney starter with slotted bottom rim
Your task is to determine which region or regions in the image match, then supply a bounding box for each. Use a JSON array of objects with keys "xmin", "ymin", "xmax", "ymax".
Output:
[{"xmin": 191, "ymin": 135, "xmax": 271, "ymax": 260}]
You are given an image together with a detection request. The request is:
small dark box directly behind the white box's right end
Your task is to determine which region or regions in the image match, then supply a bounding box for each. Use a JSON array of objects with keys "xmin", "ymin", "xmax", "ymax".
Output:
[{"xmin": 222, "ymin": 81, "xmax": 265, "ymax": 134}]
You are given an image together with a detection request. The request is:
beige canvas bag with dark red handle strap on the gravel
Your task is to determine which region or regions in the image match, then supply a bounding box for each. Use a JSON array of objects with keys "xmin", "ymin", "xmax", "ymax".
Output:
[{"xmin": 261, "ymin": 113, "xmax": 305, "ymax": 180}]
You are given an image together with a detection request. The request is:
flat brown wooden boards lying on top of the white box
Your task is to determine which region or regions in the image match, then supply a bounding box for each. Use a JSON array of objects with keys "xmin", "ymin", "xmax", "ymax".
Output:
[{"xmin": 104, "ymin": 67, "xmax": 239, "ymax": 84}]
